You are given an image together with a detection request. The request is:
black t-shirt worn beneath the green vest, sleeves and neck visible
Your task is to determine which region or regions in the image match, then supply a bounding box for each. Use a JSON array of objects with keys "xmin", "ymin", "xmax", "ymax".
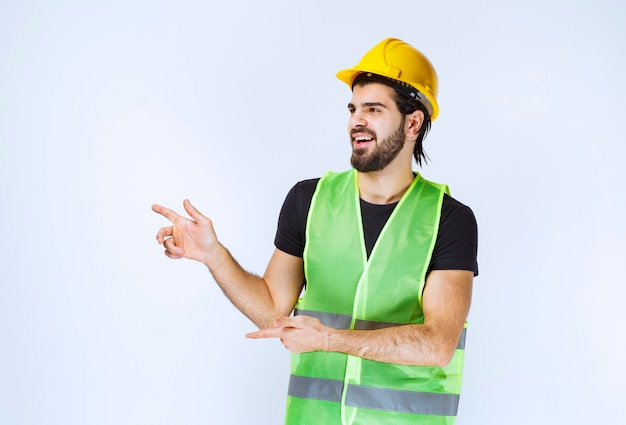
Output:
[{"xmin": 274, "ymin": 179, "xmax": 478, "ymax": 275}]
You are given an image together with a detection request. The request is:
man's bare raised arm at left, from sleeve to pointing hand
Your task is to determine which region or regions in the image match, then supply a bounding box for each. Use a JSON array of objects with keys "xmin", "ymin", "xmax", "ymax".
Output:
[{"xmin": 152, "ymin": 200, "xmax": 304, "ymax": 329}]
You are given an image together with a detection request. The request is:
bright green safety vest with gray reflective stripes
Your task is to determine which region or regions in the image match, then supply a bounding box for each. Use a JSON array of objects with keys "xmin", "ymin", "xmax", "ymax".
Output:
[{"xmin": 285, "ymin": 170, "xmax": 465, "ymax": 425}]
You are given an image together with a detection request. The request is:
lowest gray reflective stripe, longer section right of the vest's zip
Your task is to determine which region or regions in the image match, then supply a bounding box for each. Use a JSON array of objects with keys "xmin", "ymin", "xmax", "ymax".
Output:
[{"xmin": 346, "ymin": 385, "xmax": 459, "ymax": 416}]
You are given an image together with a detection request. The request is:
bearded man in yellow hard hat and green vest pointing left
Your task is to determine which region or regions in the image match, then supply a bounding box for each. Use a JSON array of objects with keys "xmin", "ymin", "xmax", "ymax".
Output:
[{"xmin": 153, "ymin": 39, "xmax": 478, "ymax": 425}]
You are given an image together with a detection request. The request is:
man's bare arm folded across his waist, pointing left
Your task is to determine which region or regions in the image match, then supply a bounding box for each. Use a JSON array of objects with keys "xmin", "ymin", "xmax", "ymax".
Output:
[{"xmin": 248, "ymin": 270, "xmax": 474, "ymax": 366}]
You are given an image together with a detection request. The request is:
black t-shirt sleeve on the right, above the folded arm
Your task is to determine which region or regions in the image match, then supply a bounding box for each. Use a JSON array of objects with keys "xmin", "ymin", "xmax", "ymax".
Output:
[{"xmin": 430, "ymin": 195, "xmax": 478, "ymax": 276}]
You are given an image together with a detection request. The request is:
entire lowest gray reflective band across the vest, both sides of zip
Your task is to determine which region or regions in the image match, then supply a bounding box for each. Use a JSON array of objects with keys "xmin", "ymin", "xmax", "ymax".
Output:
[{"xmin": 287, "ymin": 375, "xmax": 459, "ymax": 416}]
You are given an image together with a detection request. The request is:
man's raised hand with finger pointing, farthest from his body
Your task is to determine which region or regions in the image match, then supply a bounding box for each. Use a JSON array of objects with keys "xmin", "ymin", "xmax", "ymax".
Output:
[{"xmin": 152, "ymin": 199, "xmax": 218, "ymax": 264}]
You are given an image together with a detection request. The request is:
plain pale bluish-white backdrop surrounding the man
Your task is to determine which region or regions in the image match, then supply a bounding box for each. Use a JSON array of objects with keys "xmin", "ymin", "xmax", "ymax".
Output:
[{"xmin": 0, "ymin": 0, "xmax": 626, "ymax": 425}]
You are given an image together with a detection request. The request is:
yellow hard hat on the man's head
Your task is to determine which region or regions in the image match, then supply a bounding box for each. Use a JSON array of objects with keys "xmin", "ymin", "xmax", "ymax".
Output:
[{"xmin": 337, "ymin": 38, "xmax": 439, "ymax": 121}]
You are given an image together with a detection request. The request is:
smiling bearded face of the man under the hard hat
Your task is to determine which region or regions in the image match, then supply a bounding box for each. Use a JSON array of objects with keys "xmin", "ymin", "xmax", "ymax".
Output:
[{"xmin": 348, "ymin": 83, "xmax": 406, "ymax": 172}]
